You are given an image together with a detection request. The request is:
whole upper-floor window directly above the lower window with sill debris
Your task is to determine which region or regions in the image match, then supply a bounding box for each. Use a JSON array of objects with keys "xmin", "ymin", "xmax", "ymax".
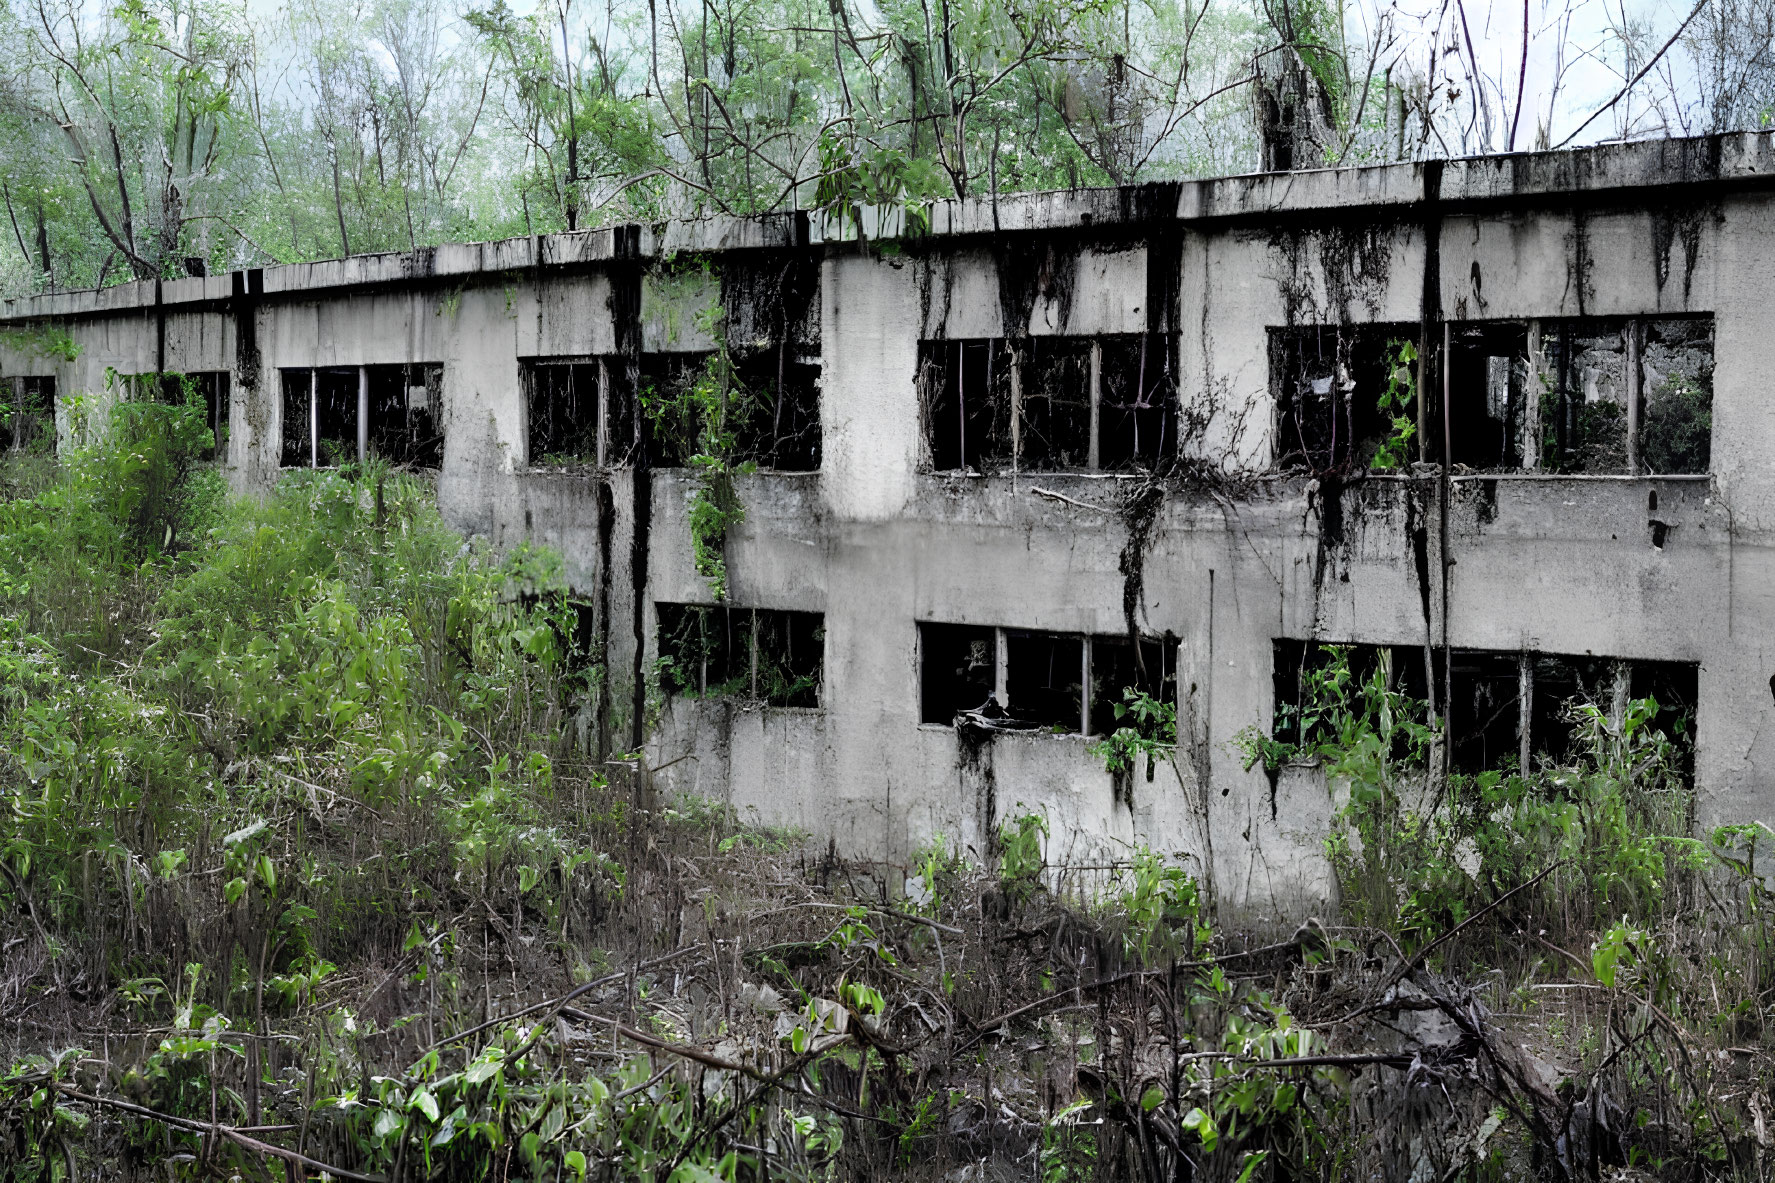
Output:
[{"xmin": 918, "ymin": 332, "xmax": 1179, "ymax": 474}]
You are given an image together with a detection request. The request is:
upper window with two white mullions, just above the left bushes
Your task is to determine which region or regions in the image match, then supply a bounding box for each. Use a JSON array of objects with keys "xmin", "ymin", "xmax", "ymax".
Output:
[{"xmin": 280, "ymin": 362, "xmax": 444, "ymax": 469}]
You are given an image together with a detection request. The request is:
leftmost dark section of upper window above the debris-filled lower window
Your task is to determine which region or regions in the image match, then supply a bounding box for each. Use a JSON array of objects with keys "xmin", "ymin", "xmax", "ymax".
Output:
[{"xmin": 918, "ymin": 339, "xmax": 1012, "ymax": 472}]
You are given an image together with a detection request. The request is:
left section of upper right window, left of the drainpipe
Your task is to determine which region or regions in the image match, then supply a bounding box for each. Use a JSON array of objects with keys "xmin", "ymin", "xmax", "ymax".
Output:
[{"xmin": 1269, "ymin": 325, "xmax": 1418, "ymax": 472}]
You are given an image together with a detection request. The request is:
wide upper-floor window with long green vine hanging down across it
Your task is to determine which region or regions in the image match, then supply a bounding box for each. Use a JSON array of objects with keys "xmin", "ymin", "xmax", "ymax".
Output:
[{"xmin": 518, "ymin": 346, "xmax": 820, "ymax": 472}]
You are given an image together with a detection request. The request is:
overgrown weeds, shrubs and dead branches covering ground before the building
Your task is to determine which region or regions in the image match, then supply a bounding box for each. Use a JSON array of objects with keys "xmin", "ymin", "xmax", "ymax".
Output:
[{"xmin": 10, "ymin": 403, "xmax": 1775, "ymax": 1183}]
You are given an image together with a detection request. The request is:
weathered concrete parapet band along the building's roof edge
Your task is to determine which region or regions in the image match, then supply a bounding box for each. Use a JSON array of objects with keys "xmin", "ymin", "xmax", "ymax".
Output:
[{"xmin": 0, "ymin": 131, "xmax": 1775, "ymax": 323}]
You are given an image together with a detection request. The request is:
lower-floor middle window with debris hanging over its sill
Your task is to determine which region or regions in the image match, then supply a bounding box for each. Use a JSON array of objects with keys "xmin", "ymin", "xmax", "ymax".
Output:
[{"xmin": 918, "ymin": 622, "xmax": 1177, "ymax": 735}]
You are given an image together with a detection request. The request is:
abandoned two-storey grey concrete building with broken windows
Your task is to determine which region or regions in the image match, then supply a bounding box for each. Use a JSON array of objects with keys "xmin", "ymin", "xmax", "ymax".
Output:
[{"xmin": 0, "ymin": 133, "xmax": 1775, "ymax": 909}]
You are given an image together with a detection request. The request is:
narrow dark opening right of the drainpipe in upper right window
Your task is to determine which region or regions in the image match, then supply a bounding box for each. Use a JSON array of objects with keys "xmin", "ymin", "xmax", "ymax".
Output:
[{"xmin": 1431, "ymin": 323, "xmax": 1539, "ymax": 471}]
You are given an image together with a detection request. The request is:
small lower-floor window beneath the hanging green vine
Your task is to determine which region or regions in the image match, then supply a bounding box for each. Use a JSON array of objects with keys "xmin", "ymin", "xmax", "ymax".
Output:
[{"xmin": 655, "ymin": 604, "xmax": 825, "ymax": 707}]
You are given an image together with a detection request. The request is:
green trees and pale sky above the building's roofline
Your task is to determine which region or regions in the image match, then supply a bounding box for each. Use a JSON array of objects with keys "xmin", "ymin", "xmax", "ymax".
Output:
[{"xmin": 0, "ymin": 0, "xmax": 1775, "ymax": 291}]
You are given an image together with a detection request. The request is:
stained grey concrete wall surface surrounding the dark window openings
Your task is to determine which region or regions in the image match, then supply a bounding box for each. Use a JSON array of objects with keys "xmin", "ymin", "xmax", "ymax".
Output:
[{"xmin": 0, "ymin": 135, "xmax": 1775, "ymax": 911}]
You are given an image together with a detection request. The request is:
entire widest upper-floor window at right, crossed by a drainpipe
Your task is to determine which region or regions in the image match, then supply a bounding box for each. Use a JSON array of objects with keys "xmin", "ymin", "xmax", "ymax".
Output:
[{"xmin": 1269, "ymin": 316, "xmax": 1713, "ymax": 474}]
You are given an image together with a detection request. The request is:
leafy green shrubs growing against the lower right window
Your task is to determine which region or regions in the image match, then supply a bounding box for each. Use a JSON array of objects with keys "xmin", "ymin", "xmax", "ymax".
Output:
[{"xmin": 1239, "ymin": 647, "xmax": 1700, "ymax": 945}]
